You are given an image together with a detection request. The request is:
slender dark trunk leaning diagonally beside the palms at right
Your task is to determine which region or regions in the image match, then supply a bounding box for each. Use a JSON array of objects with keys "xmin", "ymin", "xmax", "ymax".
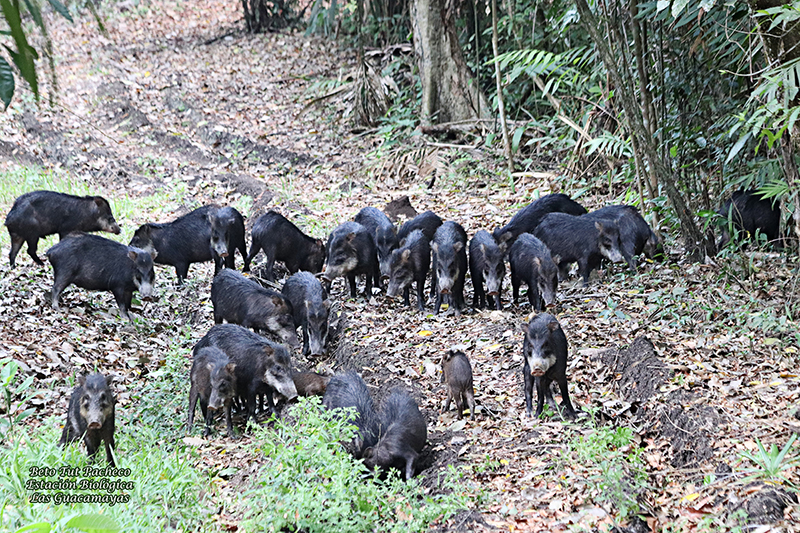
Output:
[{"xmin": 575, "ymin": 0, "xmax": 716, "ymax": 261}]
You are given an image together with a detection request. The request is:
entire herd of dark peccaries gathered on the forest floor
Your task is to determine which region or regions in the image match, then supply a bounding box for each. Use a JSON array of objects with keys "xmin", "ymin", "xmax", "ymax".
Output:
[{"xmin": 5, "ymin": 187, "xmax": 780, "ymax": 479}]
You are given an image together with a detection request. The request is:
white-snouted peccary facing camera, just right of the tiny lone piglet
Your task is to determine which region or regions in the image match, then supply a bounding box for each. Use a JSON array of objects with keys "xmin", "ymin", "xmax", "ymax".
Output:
[{"xmin": 520, "ymin": 313, "xmax": 575, "ymax": 419}]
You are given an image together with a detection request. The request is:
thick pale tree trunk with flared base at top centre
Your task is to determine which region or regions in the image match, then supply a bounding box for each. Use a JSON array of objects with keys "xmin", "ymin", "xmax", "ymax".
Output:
[{"xmin": 411, "ymin": 0, "xmax": 491, "ymax": 124}]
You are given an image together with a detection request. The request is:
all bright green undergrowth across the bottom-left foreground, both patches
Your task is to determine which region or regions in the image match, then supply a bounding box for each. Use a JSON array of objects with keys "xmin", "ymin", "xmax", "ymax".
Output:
[{"xmin": 0, "ymin": 327, "xmax": 484, "ymax": 532}]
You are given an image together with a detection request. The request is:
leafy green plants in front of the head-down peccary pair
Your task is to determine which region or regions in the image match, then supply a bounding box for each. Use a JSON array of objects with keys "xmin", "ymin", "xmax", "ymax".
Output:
[{"xmin": 240, "ymin": 398, "xmax": 482, "ymax": 533}]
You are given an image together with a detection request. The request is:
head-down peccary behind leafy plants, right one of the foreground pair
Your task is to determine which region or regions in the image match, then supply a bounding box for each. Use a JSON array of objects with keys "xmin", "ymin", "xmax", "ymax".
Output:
[{"xmin": 364, "ymin": 389, "xmax": 428, "ymax": 479}]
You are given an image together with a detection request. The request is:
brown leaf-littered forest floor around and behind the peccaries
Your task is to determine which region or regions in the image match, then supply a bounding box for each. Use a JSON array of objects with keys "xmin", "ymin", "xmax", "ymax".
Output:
[{"xmin": 0, "ymin": 0, "xmax": 800, "ymax": 531}]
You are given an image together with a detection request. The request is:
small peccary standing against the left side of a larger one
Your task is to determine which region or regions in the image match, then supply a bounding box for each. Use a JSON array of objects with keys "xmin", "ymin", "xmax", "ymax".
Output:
[{"xmin": 186, "ymin": 346, "xmax": 236, "ymax": 438}]
